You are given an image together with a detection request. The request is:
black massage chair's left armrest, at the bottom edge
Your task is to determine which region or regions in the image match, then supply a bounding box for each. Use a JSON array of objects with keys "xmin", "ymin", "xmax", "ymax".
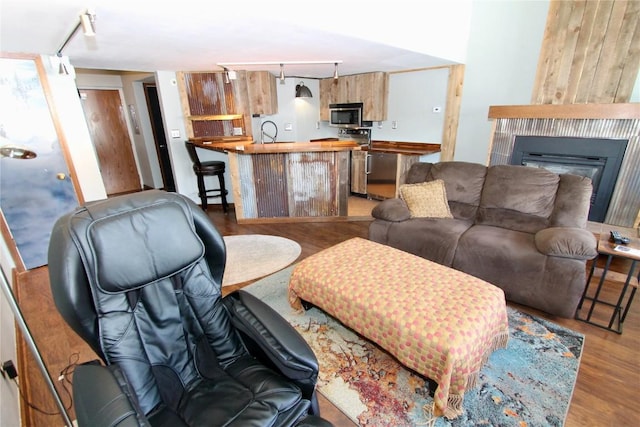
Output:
[{"xmin": 73, "ymin": 364, "xmax": 151, "ymax": 427}]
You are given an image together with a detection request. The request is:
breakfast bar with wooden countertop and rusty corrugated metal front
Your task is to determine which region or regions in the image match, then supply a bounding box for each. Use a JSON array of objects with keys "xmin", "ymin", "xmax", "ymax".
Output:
[{"xmin": 190, "ymin": 139, "xmax": 360, "ymax": 223}]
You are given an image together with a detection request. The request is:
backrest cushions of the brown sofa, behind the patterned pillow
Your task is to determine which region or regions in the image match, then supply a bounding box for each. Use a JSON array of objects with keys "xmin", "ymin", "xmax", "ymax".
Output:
[{"xmin": 407, "ymin": 161, "xmax": 592, "ymax": 233}]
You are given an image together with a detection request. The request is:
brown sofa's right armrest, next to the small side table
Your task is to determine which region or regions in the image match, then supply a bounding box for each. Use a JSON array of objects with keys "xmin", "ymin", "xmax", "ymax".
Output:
[{"xmin": 535, "ymin": 227, "xmax": 598, "ymax": 260}]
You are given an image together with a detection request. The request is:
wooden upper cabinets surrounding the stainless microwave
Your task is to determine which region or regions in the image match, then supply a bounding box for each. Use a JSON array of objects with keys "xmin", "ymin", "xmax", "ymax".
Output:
[{"xmin": 320, "ymin": 72, "xmax": 389, "ymax": 122}]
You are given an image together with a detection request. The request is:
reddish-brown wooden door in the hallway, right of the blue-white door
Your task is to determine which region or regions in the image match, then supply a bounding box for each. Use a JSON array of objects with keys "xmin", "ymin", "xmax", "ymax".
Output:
[{"xmin": 80, "ymin": 89, "xmax": 141, "ymax": 195}]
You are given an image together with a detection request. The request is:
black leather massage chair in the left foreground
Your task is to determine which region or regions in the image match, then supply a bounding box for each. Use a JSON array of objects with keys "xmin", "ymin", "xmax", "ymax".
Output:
[{"xmin": 49, "ymin": 190, "xmax": 331, "ymax": 427}]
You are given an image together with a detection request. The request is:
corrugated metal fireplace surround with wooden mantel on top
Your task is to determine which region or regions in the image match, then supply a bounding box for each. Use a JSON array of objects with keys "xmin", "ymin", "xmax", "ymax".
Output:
[{"xmin": 488, "ymin": 104, "xmax": 640, "ymax": 227}]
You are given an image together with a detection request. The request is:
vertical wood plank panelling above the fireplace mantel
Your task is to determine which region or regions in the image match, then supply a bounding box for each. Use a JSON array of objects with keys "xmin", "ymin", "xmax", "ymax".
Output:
[{"xmin": 531, "ymin": 0, "xmax": 640, "ymax": 104}]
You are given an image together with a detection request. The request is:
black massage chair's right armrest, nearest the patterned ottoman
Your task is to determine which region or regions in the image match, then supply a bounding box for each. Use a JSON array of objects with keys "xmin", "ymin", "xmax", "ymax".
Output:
[{"xmin": 223, "ymin": 290, "xmax": 319, "ymax": 402}]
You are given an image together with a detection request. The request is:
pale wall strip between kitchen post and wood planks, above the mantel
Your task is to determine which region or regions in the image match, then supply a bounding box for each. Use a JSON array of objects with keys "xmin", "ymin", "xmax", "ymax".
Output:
[{"xmin": 454, "ymin": 0, "xmax": 549, "ymax": 164}]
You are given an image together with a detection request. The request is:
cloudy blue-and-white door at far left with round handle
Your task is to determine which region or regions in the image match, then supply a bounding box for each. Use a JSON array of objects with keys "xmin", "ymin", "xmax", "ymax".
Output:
[{"xmin": 0, "ymin": 56, "xmax": 82, "ymax": 270}]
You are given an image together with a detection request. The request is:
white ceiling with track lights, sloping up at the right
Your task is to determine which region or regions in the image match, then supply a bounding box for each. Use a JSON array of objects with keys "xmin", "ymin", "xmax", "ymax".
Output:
[{"xmin": 0, "ymin": 0, "xmax": 470, "ymax": 78}]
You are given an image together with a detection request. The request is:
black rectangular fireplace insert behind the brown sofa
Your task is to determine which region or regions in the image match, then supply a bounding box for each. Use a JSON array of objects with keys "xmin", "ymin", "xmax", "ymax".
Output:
[{"xmin": 511, "ymin": 135, "xmax": 628, "ymax": 222}]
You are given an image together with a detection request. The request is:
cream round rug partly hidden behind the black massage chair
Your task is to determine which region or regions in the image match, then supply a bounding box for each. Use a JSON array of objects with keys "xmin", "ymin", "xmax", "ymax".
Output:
[{"xmin": 222, "ymin": 234, "xmax": 301, "ymax": 286}]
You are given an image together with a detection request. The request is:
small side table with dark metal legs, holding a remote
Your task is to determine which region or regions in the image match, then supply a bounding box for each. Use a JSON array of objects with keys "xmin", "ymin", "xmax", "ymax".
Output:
[{"xmin": 576, "ymin": 224, "xmax": 640, "ymax": 334}]
